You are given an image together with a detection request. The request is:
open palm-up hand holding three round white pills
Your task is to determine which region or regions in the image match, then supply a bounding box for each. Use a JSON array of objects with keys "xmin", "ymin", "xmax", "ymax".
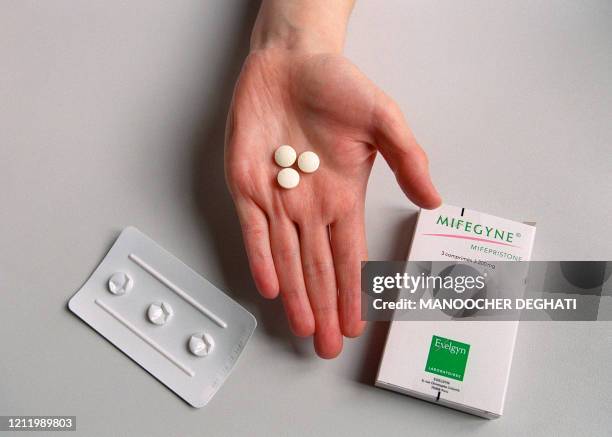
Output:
[{"xmin": 225, "ymin": 47, "xmax": 441, "ymax": 358}]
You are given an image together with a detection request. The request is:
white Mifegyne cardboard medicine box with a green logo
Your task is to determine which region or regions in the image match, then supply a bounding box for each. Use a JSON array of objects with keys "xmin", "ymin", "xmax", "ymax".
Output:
[{"xmin": 376, "ymin": 205, "xmax": 535, "ymax": 419}]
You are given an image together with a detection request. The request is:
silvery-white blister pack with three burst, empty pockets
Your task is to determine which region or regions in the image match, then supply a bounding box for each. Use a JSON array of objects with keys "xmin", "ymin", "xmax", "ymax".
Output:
[{"xmin": 68, "ymin": 227, "xmax": 257, "ymax": 408}]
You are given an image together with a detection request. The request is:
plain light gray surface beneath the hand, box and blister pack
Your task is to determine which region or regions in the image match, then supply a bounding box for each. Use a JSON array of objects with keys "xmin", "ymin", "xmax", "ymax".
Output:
[{"xmin": 0, "ymin": 0, "xmax": 612, "ymax": 436}]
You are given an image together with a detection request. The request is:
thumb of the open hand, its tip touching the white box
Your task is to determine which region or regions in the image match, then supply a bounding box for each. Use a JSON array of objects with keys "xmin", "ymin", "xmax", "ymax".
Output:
[{"xmin": 374, "ymin": 92, "xmax": 442, "ymax": 209}]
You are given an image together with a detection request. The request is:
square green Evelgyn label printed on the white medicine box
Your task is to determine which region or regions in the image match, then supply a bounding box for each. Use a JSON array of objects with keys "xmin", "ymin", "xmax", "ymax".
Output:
[{"xmin": 425, "ymin": 335, "xmax": 470, "ymax": 381}]
